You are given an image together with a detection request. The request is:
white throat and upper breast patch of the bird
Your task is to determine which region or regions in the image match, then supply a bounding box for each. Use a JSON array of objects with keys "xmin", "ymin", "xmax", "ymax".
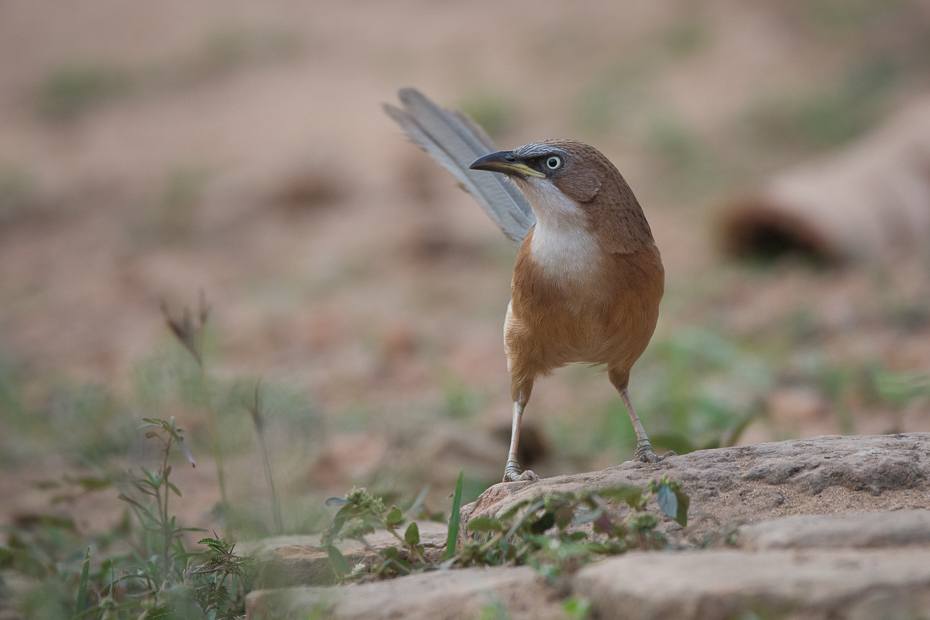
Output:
[{"xmin": 520, "ymin": 178, "xmax": 601, "ymax": 281}]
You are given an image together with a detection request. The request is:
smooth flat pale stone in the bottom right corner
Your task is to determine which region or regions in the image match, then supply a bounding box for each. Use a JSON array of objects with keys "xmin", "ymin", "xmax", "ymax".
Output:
[{"xmin": 572, "ymin": 546, "xmax": 930, "ymax": 620}]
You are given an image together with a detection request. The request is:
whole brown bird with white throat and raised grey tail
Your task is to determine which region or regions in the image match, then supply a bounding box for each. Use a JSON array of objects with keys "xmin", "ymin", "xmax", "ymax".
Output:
[{"xmin": 384, "ymin": 88, "xmax": 675, "ymax": 482}]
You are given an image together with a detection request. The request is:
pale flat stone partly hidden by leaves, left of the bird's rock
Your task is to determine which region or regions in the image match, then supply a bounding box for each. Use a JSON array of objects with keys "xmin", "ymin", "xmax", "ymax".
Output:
[{"xmin": 236, "ymin": 521, "xmax": 448, "ymax": 588}]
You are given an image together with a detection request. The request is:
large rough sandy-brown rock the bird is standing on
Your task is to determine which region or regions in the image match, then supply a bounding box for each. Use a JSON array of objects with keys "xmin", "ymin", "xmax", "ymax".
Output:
[{"xmin": 462, "ymin": 433, "xmax": 930, "ymax": 534}]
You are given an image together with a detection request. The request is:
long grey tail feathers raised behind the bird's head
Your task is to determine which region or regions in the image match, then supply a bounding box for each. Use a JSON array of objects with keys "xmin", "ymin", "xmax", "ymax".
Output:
[{"xmin": 384, "ymin": 88, "xmax": 536, "ymax": 246}]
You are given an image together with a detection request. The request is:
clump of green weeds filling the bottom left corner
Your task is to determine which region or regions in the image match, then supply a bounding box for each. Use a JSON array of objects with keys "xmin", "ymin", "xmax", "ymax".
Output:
[{"xmin": 0, "ymin": 418, "xmax": 253, "ymax": 620}]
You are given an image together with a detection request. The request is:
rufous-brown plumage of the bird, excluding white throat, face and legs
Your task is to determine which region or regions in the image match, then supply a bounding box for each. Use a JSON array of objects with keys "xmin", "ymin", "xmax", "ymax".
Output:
[{"xmin": 504, "ymin": 140, "xmax": 665, "ymax": 399}]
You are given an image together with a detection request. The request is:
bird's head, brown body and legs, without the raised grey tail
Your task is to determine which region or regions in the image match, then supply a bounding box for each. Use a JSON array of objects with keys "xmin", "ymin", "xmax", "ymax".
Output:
[{"xmin": 471, "ymin": 140, "xmax": 665, "ymax": 481}]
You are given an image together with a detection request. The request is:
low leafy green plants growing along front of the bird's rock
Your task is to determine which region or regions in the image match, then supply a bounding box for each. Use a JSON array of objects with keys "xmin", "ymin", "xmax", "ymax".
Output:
[{"xmin": 321, "ymin": 476, "xmax": 690, "ymax": 580}]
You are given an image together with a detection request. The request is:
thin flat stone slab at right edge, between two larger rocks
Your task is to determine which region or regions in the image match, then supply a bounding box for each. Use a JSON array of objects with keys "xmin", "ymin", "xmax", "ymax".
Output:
[{"xmin": 737, "ymin": 510, "xmax": 930, "ymax": 551}]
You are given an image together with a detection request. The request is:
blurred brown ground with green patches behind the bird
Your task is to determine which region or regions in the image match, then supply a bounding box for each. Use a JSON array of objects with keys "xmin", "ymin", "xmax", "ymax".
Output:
[{"xmin": 0, "ymin": 0, "xmax": 930, "ymax": 537}]
